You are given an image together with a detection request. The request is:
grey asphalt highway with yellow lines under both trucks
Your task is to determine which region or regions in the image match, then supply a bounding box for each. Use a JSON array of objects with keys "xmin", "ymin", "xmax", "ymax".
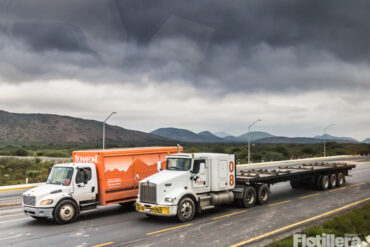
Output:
[{"xmin": 0, "ymin": 157, "xmax": 370, "ymax": 246}]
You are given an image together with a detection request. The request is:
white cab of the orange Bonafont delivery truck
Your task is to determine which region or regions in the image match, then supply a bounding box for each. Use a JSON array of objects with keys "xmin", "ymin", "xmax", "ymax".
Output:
[{"xmin": 22, "ymin": 163, "xmax": 98, "ymax": 224}]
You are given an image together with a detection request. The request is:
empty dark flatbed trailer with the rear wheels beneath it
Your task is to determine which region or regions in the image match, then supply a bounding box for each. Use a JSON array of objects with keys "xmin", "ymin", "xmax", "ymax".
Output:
[{"xmin": 233, "ymin": 163, "xmax": 356, "ymax": 208}]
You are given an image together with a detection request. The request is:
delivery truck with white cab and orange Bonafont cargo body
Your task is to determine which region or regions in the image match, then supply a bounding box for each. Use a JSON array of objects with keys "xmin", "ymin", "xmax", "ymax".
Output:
[{"xmin": 23, "ymin": 146, "xmax": 182, "ymax": 224}]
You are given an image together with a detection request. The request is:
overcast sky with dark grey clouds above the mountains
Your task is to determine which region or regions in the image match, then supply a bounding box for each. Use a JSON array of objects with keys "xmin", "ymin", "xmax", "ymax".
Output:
[{"xmin": 0, "ymin": 0, "xmax": 370, "ymax": 140}]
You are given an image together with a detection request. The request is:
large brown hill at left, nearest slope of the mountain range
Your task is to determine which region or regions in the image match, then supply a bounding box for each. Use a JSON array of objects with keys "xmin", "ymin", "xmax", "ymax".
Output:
[{"xmin": 0, "ymin": 111, "xmax": 175, "ymax": 147}]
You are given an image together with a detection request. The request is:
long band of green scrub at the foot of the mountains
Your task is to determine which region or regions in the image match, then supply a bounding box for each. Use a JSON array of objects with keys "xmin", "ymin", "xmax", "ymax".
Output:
[{"xmin": 0, "ymin": 142, "xmax": 370, "ymax": 163}]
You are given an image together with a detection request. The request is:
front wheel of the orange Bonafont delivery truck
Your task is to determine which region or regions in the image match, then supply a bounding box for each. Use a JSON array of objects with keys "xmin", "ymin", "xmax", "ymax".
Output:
[{"xmin": 54, "ymin": 199, "xmax": 78, "ymax": 224}]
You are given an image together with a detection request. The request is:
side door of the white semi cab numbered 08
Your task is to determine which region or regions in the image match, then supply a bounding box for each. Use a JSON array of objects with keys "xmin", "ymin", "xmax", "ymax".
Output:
[{"xmin": 191, "ymin": 159, "xmax": 210, "ymax": 193}]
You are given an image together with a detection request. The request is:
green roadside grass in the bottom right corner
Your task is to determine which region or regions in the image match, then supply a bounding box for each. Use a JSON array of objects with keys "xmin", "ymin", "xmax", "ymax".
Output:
[{"xmin": 269, "ymin": 203, "xmax": 370, "ymax": 247}]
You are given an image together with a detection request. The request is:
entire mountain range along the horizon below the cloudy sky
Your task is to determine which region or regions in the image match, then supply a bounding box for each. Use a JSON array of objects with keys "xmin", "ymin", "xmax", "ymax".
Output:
[{"xmin": 0, "ymin": 110, "xmax": 370, "ymax": 147}]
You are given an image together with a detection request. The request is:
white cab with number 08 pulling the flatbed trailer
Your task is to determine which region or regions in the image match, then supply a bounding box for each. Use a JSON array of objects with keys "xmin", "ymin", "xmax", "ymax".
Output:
[{"xmin": 136, "ymin": 153, "xmax": 235, "ymax": 222}]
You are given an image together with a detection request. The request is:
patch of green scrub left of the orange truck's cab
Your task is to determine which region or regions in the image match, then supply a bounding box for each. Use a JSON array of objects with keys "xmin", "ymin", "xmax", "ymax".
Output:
[{"xmin": 0, "ymin": 158, "xmax": 54, "ymax": 185}]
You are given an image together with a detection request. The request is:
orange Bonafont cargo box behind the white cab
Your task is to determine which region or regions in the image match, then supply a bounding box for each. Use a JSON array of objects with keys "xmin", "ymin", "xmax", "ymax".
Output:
[{"xmin": 73, "ymin": 147, "xmax": 183, "ymax": 205}]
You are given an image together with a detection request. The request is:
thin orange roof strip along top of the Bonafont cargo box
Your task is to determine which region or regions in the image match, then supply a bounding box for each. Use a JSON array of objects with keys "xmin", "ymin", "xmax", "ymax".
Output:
[{"xmin": 73, "ymin": 146, "xmax": 183, "ymax": 155}]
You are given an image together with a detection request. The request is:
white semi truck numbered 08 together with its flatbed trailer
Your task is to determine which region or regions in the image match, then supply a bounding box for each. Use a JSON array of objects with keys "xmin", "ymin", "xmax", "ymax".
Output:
[{"xmin": 136, "ymin": 153, "xmax": 355, "ymax": 222}]
